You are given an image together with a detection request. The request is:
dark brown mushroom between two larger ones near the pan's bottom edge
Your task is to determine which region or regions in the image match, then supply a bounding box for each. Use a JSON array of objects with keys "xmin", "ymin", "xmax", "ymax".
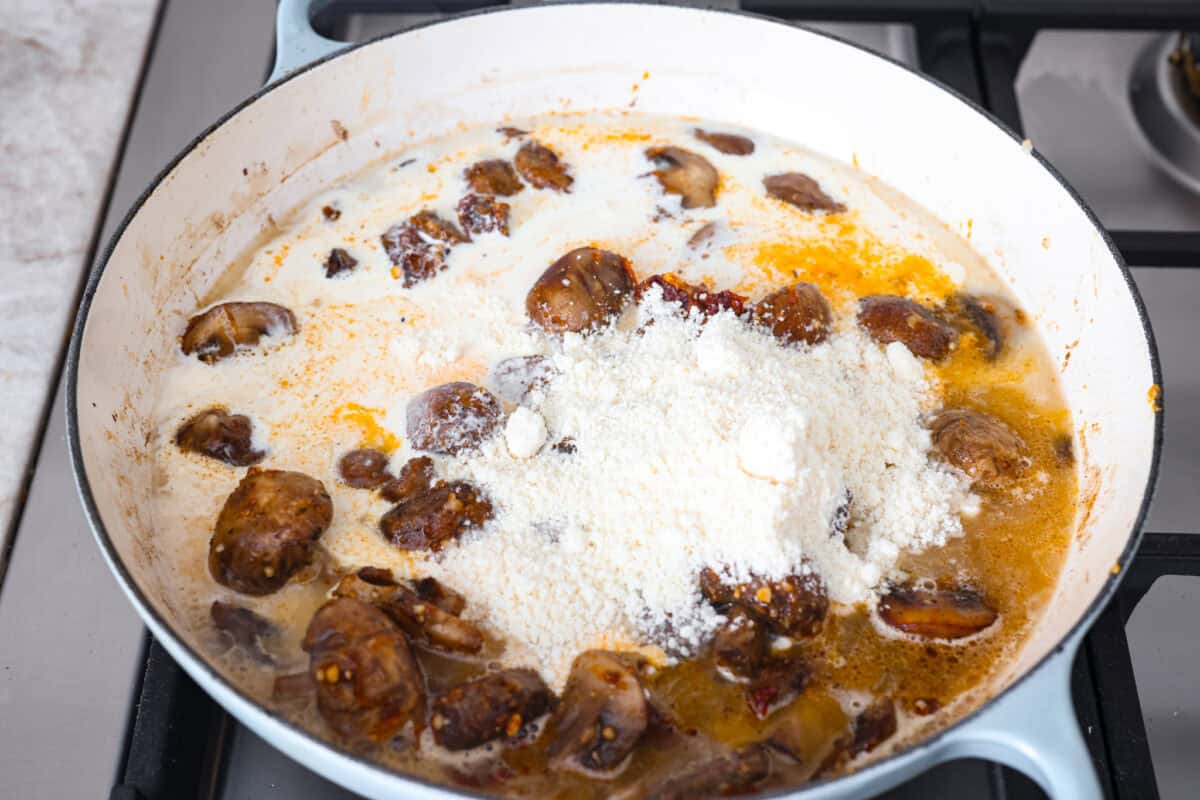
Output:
[{"xmin": 430, "ymin": 669, "xmax": 551, "ymax": 751}]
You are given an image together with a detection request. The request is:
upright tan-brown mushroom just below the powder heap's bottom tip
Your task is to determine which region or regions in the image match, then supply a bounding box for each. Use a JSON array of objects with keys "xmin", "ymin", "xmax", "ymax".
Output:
[{"xmin": 547, "ymin": 650, "xmax": 648, "ymax": 771}]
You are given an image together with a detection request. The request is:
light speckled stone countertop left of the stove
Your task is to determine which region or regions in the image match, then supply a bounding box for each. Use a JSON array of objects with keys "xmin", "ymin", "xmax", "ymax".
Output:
[{"xmin": 0, "ymin": 0, "xmax": 157, "ymax": 549}]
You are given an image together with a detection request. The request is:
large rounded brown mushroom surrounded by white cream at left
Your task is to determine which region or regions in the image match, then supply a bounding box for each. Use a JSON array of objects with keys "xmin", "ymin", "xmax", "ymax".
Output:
[{"xmin": 209, "ymin": 468, "xmax": 334, "ymax": 595}]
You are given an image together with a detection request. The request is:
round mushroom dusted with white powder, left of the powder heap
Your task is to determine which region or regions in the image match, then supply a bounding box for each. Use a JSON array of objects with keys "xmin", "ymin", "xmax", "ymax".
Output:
[{"xmin": 404, "ymin": 380, "xmax": 502, "ymax": 456}]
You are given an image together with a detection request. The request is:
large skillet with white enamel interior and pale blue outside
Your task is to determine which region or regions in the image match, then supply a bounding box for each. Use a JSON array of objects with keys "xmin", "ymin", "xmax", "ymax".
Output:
[{"xmin": 67, "ymin": 0, "xmax": 1162, "ymax": 800}]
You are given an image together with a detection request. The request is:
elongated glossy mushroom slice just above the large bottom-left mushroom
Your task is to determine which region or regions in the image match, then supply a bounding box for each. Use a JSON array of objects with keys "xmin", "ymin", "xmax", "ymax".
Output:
[{"xmin": 334, "ymin": 569, "xmax": 484, "ymax": 654}]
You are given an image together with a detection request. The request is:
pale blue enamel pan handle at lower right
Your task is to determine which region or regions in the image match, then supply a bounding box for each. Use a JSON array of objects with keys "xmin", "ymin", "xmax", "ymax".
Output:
[{"xmin": 940, "ymin": 636, "xmax": 1104, "ymax": 800}]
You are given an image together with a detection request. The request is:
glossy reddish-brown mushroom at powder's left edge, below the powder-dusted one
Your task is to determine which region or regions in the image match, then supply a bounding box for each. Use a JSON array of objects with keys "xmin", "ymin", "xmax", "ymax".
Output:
[{"xmin": 379, "ymin": 481, "xmax": 492, "ymax": 551}]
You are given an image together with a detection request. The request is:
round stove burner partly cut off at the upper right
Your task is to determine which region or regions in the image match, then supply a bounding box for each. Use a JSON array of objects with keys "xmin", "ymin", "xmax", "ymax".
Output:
[{"xmin": 1129, "ymin": 34, "xmax": 1200, "ymax": 192}]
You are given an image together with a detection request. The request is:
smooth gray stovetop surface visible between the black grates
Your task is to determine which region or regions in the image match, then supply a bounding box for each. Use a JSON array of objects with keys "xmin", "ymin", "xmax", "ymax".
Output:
[{"xmin": 0, "ymin": 0, "xmax": 1200, "ymax": 800}]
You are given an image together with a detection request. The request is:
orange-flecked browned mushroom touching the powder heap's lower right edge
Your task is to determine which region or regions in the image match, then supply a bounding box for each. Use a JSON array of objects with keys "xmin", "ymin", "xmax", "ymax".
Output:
[{"xmin": 700, "ymin": 570, "xmax": 829, "ymax": 637}]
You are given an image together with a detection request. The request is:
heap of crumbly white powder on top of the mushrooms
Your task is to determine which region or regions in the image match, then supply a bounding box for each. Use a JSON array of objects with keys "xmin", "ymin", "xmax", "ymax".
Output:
[{"xmin": 438, "ymin": 294, "xmax": 968, "ymax": 686}]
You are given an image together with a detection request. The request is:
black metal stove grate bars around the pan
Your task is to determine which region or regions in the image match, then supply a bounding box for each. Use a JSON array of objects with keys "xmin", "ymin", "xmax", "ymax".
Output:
[{"xmin": 110, "ymin": 0, "xmax": 1200, "ymax": 800}]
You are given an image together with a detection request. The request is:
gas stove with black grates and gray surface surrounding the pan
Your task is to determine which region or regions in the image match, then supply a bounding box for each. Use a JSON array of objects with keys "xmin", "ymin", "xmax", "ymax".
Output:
[{"xmin": 0, "ymin": 0, "xmax": 1200, "ymax": 800}]
